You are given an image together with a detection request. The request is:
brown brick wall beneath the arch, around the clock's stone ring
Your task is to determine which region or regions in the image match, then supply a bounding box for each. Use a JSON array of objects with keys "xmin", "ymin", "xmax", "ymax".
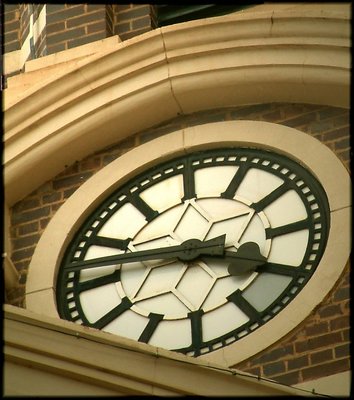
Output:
[{"xmin": 8, "ymin": 104, "xmax": 350, "ymax": 384}]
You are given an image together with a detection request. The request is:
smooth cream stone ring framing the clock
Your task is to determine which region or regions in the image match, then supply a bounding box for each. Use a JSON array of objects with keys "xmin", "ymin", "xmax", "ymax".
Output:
[{"xmin": 26, "ymin": 121, "xmax": 351, "ymax": 366}]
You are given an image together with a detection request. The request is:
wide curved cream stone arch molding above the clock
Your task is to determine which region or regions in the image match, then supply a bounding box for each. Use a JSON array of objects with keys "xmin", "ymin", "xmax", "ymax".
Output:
[{"xmin": 4, "ymin": 4, "xmax": 350, "ymax": 206}]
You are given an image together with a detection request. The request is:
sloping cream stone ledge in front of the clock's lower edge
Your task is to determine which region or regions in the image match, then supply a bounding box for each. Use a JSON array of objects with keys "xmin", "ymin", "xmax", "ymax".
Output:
[{"xmin": 3, "ymin": 305, "xmax": 317, "ymax": 397}]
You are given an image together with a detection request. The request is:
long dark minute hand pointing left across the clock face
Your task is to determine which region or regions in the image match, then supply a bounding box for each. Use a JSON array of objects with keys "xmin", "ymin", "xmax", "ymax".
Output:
[{"xmin": 67, "ymin": 235, "xmax": 226, "ymax": 271}]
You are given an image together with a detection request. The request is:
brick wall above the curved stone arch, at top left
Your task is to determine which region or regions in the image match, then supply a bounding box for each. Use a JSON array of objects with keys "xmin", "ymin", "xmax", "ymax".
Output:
[{"xmin": 4, "ymin": 3, "xmax": 156, "ymax": 75}]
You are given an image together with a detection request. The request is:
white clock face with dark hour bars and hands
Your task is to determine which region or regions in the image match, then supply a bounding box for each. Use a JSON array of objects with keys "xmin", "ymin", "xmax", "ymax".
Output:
[{"xmin": 57, "ymin": 148, "xmax": 329, "ymax": 356}]
